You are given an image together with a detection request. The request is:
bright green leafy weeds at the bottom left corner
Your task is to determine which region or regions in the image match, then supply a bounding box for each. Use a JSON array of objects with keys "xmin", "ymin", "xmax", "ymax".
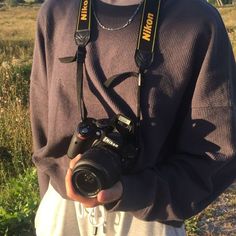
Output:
[{"xmin": 0, "ymin": 168, "xmax": 39, "ymax": 236}]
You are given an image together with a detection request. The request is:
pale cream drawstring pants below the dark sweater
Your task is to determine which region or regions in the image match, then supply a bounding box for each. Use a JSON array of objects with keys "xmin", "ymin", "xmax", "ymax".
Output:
[{"xmin": 35, "ymin": 185, "xmax": 186, "ymax": 236}]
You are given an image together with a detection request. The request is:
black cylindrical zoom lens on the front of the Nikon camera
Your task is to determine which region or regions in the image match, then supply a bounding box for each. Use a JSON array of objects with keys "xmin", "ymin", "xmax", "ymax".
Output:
[{"xmin": 72, "ymin": 148, "xmax": 121, "ymax": 198}]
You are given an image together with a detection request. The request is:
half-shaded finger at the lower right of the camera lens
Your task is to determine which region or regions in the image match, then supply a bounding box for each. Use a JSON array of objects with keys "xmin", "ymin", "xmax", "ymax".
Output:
[{"xmin": 97, "ymin": 181, "xmax": 123, "ymax": 204}]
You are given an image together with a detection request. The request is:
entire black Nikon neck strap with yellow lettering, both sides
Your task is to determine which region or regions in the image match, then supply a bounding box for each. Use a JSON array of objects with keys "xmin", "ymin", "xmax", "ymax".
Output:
[{"xmin": 59, "ymin": 0, "xmax": 161, "ymax": 126}]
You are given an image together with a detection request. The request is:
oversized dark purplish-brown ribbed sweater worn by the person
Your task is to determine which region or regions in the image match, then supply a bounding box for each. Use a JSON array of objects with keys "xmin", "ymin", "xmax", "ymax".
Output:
[{"xmin": 30, "ymin": 0, "xmax": 236, "ymax": 225}]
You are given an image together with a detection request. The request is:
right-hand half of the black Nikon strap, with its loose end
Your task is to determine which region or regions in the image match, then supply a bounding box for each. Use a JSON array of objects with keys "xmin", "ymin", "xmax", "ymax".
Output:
[{"xmin": 104, "ymin": 0, "xmax": 161, "ymax": 127}]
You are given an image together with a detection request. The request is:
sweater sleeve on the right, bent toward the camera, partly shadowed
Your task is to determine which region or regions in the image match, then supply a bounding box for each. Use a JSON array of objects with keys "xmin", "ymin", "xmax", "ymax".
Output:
[{"xmin": 106, "ymin": 6, "xmax": 236, "ymax": 224}]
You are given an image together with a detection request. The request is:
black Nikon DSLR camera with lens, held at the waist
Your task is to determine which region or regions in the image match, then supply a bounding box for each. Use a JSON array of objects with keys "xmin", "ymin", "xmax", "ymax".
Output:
[{"xmin": 67, "ymin": 115, "xmax": 137, "ymax": 198}]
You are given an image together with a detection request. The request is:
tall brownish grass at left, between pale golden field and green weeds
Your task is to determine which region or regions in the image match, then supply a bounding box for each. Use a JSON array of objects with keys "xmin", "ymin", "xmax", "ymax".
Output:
[{"xmin": 0, "ymin": 57, "xmax": 32, "ymax": 184}]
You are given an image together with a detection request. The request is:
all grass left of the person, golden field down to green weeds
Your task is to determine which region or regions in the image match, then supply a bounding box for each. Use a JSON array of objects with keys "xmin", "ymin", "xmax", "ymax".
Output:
[{"xmin": 0, "ymin": 7, "xmax": 39, "ymax": 236}]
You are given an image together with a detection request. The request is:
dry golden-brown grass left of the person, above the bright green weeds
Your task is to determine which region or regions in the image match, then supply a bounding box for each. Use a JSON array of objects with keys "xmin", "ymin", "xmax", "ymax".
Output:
[{"xmin": 0, "ymin": 4, "xmax": 35, "ymax": 184}]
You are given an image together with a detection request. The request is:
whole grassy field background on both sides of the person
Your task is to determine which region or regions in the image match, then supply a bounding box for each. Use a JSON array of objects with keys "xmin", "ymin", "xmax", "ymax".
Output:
[{"xmin": 0, "ymin": 5, "xmax": 236, "ymax": 236}]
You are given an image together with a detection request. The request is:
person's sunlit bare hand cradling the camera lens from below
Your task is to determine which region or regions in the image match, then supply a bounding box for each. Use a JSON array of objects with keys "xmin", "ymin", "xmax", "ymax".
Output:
[{"xmin": 65, "ymin": 155, "xmax": 123, "ymax": 208}]
